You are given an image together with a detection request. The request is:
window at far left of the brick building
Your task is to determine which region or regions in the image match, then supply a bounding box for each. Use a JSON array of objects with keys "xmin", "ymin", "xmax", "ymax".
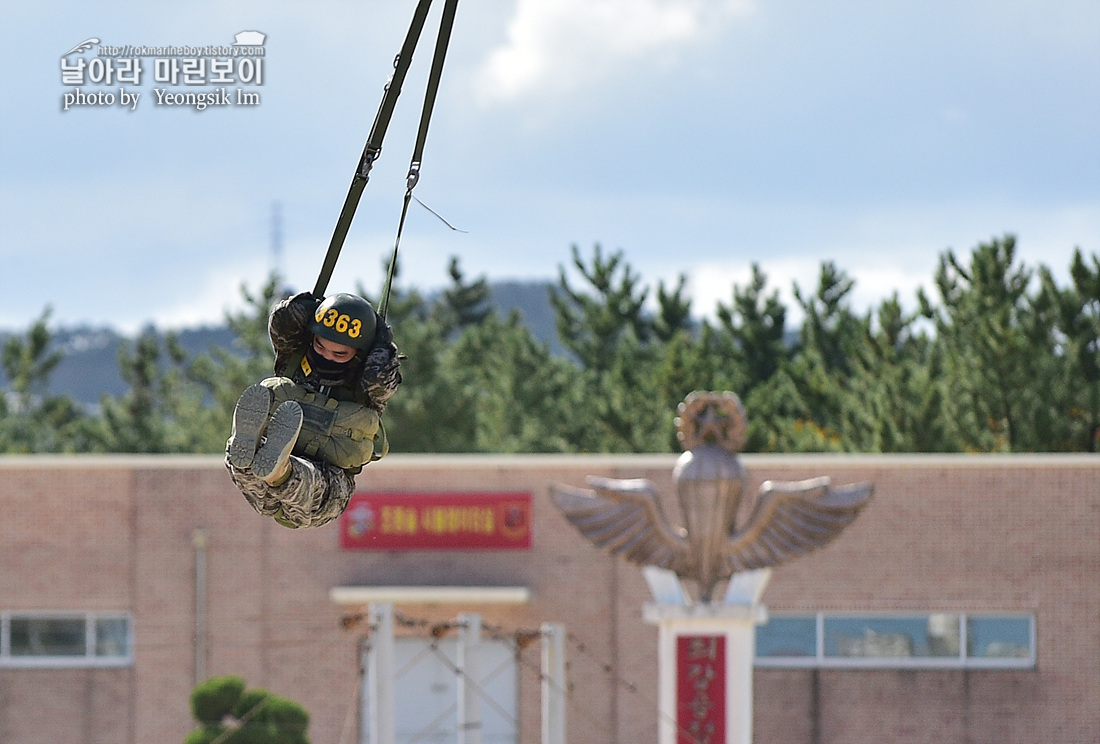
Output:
[{"xmin": 0, "ymin": 612, "xmax": 133, "ymax": 667}]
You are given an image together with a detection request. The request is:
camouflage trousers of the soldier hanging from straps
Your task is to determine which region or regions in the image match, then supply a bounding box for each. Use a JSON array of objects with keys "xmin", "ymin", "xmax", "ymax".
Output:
[{"xmin": 226, "ymin": 457, "xmax": 355, "ymax": 527}]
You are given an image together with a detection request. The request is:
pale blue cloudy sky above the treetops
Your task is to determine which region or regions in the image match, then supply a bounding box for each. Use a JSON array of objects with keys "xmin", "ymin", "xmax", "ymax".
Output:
[{"xmin": 0, "ymin": 0, "xmax": 1100, "ymax": 332}]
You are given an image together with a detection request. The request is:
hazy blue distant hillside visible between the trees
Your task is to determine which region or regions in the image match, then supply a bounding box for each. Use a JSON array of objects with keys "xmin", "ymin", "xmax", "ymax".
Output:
[{"xmin": 0, "ymin": 282, "xmax": 561, "ymax": 405}]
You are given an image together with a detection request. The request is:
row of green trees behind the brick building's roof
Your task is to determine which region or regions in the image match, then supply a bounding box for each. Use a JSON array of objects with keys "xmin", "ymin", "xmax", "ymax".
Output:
[{"xmin": 0, "ymin": 236, "xmax": 1100, "ymax": 453}]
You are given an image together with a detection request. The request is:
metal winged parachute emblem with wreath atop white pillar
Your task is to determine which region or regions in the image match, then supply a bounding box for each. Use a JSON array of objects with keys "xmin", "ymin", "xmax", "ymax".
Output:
[{"xmin": 551, "ymin": 392, "xmax": 872, "ymax": 602}]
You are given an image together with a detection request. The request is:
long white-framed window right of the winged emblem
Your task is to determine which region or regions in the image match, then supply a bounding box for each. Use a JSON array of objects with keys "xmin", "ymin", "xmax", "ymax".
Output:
[{"xmin": 756, "ymin": 612, "xmax": 1035, "ymax": 669}]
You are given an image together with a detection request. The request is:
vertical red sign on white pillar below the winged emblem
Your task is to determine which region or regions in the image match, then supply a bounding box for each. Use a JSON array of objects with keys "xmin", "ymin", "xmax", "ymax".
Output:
[{"xmin": 677, "ymin": 635, "xmax": 726, "ymax": 744}]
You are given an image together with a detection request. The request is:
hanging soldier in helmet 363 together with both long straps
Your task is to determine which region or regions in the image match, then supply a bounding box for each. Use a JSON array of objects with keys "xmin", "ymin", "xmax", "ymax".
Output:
[{"xmin": 226, "ymin": 0, "xmax": 458, "ymax": 527}]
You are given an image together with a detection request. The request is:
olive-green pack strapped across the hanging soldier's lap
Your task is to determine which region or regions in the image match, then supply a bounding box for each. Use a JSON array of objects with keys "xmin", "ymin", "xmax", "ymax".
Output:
[{"xmin": 260, "ymin": 378, "xmax": 389, "ymax": 473}]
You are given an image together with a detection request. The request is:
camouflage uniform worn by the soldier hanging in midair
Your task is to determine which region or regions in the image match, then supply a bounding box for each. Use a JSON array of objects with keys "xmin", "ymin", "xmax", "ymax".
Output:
[{"xmin": 226, "ymin": 293, "xmax": 402, "ymax": 527}]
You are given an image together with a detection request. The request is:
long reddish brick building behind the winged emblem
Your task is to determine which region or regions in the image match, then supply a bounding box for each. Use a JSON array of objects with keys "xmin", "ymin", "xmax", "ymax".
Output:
[{"xmin": 0, "ymin": 456, "xmax": 1100, "ymax": 744}]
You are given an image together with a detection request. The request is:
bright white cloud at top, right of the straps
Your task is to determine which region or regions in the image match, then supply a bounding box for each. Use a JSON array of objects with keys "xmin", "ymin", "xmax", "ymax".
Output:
[{"xmin": 475, "ymin": 0, "xmax": 754, "ymax": 101}]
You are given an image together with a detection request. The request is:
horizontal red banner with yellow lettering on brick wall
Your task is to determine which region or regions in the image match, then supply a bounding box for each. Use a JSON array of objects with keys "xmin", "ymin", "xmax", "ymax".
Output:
[{"xmin": 340, "ymin": 492, "xmax": 531, "ymax": 550}]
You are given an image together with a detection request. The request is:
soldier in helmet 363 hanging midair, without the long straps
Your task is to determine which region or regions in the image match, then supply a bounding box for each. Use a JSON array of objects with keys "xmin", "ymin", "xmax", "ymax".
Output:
[{"xmin": 226, "ymin": 292, "xmax": 402, "ymax": 527}]
